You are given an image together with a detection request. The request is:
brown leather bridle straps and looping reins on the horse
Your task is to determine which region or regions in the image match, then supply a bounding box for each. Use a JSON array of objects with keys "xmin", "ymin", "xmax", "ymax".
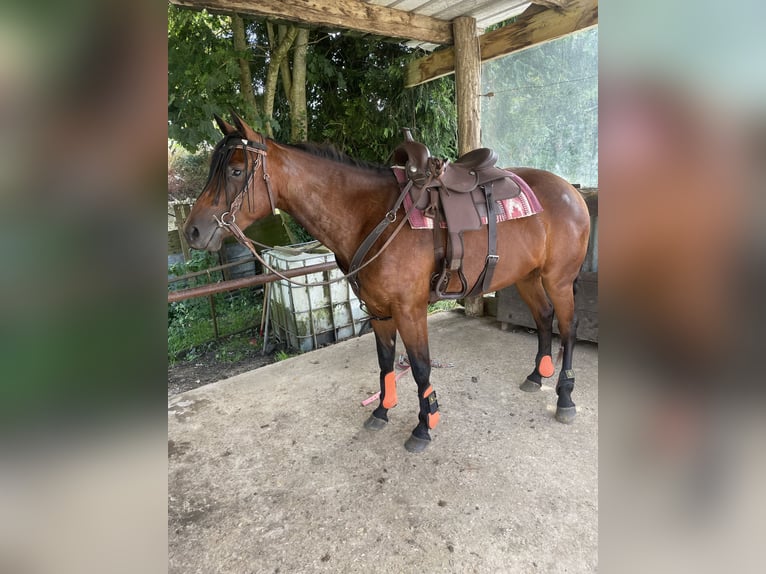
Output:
[{"xmin": 213, "ymin": 134, "xmax": 425, "ymax": 290}]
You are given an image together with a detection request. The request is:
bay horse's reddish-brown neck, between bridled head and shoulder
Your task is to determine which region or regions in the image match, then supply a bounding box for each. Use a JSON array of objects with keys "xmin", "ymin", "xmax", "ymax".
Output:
[{"xmin": 279, "ymin": 154, "xmax": 396, "ymax": 267}]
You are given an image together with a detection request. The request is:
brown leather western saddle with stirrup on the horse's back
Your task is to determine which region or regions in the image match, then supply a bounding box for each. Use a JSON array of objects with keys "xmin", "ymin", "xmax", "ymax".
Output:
[{"xmin": 392, "ymin": 128, "xmax": 521, "ymax": 301}]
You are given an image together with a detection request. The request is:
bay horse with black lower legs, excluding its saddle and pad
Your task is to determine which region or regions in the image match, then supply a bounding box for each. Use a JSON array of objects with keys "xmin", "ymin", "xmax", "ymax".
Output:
[{"xmin": 184, "ymin": 114, "xmax": 590, "ymax": 452}]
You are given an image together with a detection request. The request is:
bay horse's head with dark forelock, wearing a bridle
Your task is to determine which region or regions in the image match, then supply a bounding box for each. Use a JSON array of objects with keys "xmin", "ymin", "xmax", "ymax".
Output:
[{"xmin": 183, "ymin": 114, "xmax": 274, "ymax": 251}]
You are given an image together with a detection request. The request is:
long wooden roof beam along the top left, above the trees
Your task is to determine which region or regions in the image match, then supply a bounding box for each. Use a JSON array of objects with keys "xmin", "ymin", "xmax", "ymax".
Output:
[{"xmin": 170, "ymin": 0, "xmax": 452, "ymax": 45}]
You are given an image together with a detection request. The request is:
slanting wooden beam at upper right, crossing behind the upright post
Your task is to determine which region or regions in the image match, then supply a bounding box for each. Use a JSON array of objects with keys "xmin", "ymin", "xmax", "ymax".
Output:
[{"xmin": 404, "ymin": 0, "xmax": 598, "ymax": 88}]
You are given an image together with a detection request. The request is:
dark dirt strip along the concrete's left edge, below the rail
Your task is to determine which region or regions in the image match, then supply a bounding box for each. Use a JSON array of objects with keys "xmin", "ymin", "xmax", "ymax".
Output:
[{"xmin": 168, "ymin": 351, "xmax": 276, "ymax": 397}]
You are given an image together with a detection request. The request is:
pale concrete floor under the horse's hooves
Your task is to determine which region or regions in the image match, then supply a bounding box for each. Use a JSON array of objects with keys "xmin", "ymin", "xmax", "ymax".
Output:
[{"xmin": 168, "ymin": 311, "xmax": 598, "ymax": 574}]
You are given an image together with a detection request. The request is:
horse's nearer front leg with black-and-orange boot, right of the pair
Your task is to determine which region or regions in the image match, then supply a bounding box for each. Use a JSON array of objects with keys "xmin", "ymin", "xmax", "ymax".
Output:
[{"xmin": 394, "ymin": 305, "xmax": 440, "ymax": 452}]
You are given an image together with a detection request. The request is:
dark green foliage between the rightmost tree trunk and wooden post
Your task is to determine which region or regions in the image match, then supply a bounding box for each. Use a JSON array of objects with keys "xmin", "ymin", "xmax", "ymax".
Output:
[{"xmin": 307, "ymin": 34, "xmax": 457, "ymax": 163}]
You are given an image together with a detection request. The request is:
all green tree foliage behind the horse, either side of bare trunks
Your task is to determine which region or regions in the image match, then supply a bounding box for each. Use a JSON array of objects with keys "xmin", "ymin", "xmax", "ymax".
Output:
[{"xmin": 168, "ymin": 9, "xmax": 457, "ymax": 163}]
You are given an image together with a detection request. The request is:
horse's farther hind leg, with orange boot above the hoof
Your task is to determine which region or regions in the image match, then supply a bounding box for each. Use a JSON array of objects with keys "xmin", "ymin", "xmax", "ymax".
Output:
[{"xmin": 516, "ymin": 272, "xmax": 554, "ymax": 392}]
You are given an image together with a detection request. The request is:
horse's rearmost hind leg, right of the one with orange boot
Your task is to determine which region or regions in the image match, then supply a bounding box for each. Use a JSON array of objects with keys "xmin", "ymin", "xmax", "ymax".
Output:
[{"xmin": 546, "ymin": 280, "xmax": 577, "ymax": 423}]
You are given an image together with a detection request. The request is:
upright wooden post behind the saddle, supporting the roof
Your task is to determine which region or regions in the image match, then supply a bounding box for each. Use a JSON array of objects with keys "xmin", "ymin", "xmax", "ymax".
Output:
[{"xmin": 452, "ymin": 16, "xmax": 484, "ymax": 317}]
